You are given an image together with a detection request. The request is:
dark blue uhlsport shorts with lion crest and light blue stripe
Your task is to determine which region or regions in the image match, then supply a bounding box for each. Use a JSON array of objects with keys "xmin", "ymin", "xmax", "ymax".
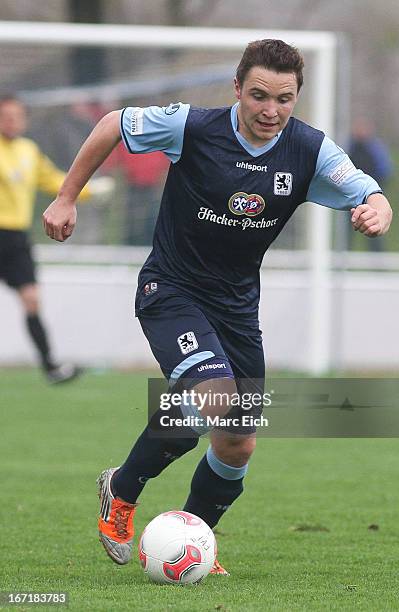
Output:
[{"xmin": 136, "ymin": 283, "xmax": 265, "ymax": 434}]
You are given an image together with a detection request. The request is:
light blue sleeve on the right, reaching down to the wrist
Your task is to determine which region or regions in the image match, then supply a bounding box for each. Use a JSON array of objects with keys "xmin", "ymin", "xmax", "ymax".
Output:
[{"xmin": 307, "ymin": 136, "xmax": 382, "ymax": 210}]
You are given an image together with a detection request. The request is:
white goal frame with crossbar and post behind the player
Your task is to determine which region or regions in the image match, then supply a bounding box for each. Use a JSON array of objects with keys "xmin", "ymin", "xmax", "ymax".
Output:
[{"xmin": 0, "ymin": 21, "xmax": 338, "ymax": 375}]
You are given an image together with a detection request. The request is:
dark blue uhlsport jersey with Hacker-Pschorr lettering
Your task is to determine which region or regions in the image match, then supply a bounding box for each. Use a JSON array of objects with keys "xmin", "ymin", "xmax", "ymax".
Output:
[{"xmin": 122, "ymin": 105, "xmax": 378, "ymax": 318}]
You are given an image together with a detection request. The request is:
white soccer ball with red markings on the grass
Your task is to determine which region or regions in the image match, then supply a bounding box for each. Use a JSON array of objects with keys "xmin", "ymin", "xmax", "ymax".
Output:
[{"xmin": 139, "ymin": 510, "xmax": 216, "ymax": 584}]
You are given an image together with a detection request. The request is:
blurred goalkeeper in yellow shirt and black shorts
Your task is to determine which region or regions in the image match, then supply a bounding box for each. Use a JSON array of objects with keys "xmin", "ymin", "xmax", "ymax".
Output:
[{"xmin": 0, "ymin": 95, "xmax": 109, "ymax": 383}]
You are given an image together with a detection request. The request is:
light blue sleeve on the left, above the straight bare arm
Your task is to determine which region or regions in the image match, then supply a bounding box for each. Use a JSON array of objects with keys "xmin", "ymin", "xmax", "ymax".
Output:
[{"xmin": 120, "ymin": 102, "xmax": 190, "ymax": 163}]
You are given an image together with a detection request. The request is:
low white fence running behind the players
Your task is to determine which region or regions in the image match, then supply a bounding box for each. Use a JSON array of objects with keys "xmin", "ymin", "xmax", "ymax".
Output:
[{"xmin": 0, "ymin": 245, "xmax": 399, "ymax": 372}]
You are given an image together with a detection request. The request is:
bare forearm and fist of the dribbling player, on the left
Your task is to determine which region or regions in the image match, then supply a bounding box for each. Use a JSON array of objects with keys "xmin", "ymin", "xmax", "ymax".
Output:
[{"xmin": 43, "ymin": 111, "xmax": 121, "ymax": 242}]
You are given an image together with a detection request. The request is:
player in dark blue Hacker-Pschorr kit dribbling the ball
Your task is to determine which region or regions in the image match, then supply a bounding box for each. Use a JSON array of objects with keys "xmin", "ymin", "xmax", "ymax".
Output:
[{"xmin": 44, "ymin": 40, "xmax": 392, "ymax": 574}]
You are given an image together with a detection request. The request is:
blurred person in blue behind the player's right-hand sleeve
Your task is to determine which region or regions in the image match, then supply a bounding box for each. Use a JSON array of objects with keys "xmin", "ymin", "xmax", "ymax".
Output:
[{"xmin": 347, "ymin": 117, "xmax": 393, "ymax": 252}]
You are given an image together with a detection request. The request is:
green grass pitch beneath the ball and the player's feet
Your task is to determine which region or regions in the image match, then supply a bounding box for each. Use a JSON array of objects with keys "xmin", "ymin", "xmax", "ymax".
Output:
[{"xmin": 0, "ymin": 370, "xmax": 399, "ymax": 612}]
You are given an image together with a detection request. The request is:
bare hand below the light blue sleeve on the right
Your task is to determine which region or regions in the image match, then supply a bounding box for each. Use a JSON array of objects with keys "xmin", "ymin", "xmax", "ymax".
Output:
[{"xmin": 351, "ymin": 193, "xmax": 392, "ymax": 237}]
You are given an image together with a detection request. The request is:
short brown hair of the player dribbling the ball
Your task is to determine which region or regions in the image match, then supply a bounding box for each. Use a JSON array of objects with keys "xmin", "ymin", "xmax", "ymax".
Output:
[{"xmin": 236, "ymin": 38, "xmax": 304, "ymax": 91}]
